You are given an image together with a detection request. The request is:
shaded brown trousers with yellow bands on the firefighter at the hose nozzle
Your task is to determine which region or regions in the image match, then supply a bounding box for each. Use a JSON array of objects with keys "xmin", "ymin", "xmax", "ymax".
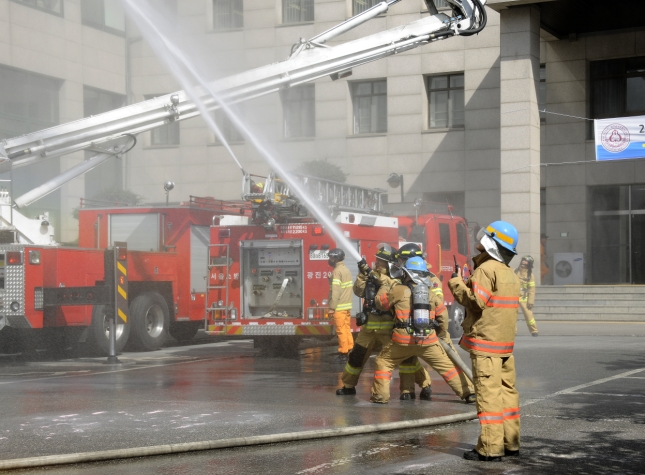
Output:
[{"xmin": 341, "ymin": 329, "xmax": 431, "ymax": 394}]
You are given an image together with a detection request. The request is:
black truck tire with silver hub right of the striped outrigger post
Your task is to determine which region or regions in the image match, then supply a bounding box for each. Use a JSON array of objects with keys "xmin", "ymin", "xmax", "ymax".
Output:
[{"xmin": 130, "ymin": 292, "xmax": 170, "ymax": 351}]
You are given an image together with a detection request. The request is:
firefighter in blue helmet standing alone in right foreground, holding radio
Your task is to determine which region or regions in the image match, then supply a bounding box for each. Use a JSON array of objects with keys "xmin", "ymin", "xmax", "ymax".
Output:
[{"xmin": 448, "ymin": 221, "xmax": 520, "ymax": 462}]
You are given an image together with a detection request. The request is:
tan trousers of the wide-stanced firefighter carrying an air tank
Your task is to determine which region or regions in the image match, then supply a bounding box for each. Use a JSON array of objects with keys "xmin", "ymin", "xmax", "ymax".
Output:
[{"xmin": 370, "ymin": 342, "xmax": 474, "ymax": 404}]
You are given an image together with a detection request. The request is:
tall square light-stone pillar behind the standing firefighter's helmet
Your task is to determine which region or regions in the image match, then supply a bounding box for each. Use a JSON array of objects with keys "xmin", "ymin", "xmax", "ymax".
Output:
[{"xmin": 500, "ymin": 6, "xmax": 540, "ymax": 283}]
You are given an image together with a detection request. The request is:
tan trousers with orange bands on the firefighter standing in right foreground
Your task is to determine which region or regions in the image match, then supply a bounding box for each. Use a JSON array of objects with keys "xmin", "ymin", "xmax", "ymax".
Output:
[{"xmin": 470, "ymin": 354, "xmax": 520, "ymax": 457}]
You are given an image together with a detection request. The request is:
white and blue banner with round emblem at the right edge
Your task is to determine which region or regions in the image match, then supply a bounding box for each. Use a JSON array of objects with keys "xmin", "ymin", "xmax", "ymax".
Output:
[{"xmin": 594, "ymin": 115, "xmax": 645, "ymax": 160}]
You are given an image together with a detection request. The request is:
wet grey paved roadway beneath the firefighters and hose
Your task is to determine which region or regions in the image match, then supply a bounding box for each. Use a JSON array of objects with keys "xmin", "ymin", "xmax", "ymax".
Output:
[{"xmin": 0, "ymin": 322, "xmax": 645, "ymax": 475}]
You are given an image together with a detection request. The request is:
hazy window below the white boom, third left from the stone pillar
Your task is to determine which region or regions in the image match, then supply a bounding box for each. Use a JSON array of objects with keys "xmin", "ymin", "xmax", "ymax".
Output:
[{"xmin": 282, "ymin": 84, "xmax": 316, "ymax": 138}]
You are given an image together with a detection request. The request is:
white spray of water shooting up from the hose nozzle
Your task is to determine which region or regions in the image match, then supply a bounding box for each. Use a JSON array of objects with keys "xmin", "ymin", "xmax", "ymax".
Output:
[{"xmin": 121, "ymin": 0, "xmax": 361, "ymax": 260}]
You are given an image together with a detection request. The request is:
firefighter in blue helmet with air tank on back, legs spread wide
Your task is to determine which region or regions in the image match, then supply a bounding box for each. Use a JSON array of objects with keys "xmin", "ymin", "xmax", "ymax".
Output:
[{"xmin": 370, "ymin": 257, "xmax": 474, "ymax": 404}]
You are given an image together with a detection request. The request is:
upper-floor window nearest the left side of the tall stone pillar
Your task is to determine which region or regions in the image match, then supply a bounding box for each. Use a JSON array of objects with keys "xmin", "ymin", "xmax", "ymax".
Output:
[{"xmin": 427, "ymin": 74, "xmax": 465, "ymax": 128}]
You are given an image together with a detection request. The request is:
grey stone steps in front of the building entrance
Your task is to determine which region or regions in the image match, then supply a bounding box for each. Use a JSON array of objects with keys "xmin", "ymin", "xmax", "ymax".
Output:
[{"xmin": 519, "ymin": 285, "xmax": 645, "ymax": 322}]
